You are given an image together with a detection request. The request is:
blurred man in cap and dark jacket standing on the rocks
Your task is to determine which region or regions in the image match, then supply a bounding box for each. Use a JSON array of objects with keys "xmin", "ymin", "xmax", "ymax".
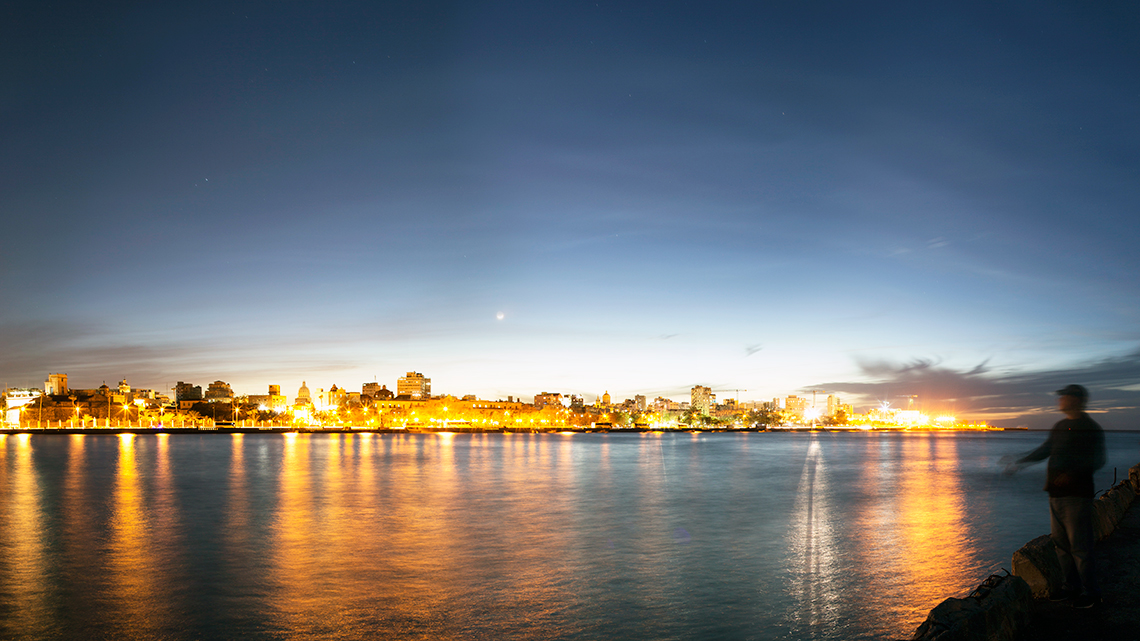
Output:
[{"xmin": 1005, "ymin": 386, "xmax": 1105, "ymax": 608}]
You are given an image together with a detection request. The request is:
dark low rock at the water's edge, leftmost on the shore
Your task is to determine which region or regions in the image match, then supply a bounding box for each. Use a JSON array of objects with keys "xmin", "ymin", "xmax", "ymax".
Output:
[{"xmin": 913, "ymin": 574, "xmax": 1032, "ymax": 641}]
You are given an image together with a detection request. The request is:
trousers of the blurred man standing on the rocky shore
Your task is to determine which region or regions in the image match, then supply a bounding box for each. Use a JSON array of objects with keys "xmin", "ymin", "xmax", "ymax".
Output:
[{"xmin": 1049, "ymin": 496, "xmax": 1100, "ymax": 597}]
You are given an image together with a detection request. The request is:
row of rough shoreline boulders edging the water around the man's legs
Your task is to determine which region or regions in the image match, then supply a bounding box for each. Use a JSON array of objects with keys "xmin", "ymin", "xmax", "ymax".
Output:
[{"xmin": 911, "ymin": 464, "xmax": 1140, "ymax": 641}]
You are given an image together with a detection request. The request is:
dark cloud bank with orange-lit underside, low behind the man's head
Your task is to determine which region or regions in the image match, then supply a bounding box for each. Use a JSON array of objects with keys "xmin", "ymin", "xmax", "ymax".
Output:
[{"xmin": 807, "ymin": 349, "xmax": 1140, "ymax": 429}]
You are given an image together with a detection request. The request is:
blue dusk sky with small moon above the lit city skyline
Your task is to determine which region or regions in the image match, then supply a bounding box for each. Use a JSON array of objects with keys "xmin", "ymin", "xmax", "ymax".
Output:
[{"xmin": 0, "ymin": 1, "xmax": 1140, "ymax": 429}]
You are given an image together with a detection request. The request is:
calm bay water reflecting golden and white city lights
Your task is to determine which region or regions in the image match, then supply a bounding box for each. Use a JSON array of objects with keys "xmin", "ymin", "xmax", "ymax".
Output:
[{"xmin": 0, "ymin": 432, "xmax": 1140, "ymax": 639}]
